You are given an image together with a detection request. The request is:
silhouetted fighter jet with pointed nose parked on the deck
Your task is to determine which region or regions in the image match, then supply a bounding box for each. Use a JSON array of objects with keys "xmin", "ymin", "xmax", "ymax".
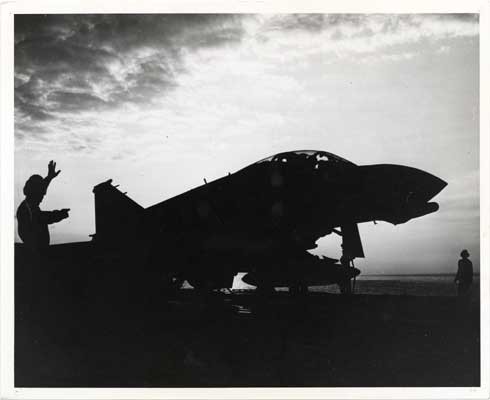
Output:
[{"xmin": 89, "ymin": 150, "xmax": 447, "ymax": 290}]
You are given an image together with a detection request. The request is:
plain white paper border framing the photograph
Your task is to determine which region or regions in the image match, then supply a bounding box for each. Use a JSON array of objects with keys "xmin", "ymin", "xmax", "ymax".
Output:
[{"xmin": 0, "ymin": 0, "xmax": 490, "ymax": 399}]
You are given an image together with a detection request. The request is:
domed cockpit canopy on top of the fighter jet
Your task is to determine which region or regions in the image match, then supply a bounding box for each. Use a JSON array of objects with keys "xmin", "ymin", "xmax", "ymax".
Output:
[{"xmin": 255, "ymin": 150, "xmax": 356, "ymax": 169}]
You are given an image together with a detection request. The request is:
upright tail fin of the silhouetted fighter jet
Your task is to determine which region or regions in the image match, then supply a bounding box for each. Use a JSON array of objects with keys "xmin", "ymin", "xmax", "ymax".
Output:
[{"xmin": 93, "ymin": 179, "xmax": 144, "ymax": 243}]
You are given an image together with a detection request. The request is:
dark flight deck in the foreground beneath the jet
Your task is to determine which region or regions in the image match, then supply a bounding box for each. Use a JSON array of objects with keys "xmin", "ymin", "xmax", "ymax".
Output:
[{"xmin": 15, "ymin": 270, "xmax": 480, "ymax": 387}]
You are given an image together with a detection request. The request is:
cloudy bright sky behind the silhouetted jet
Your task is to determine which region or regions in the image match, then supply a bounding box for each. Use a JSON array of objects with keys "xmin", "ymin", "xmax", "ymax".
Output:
[{"xmin": 15, "ymin": 14, "xmax": 479, "ymax": 273}]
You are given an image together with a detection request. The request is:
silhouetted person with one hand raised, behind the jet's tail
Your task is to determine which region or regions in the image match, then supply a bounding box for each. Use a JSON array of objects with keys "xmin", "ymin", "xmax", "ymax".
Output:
[{"xmin": 17, "ymin": 161, "xmax": 70, "ymax": 253}]
